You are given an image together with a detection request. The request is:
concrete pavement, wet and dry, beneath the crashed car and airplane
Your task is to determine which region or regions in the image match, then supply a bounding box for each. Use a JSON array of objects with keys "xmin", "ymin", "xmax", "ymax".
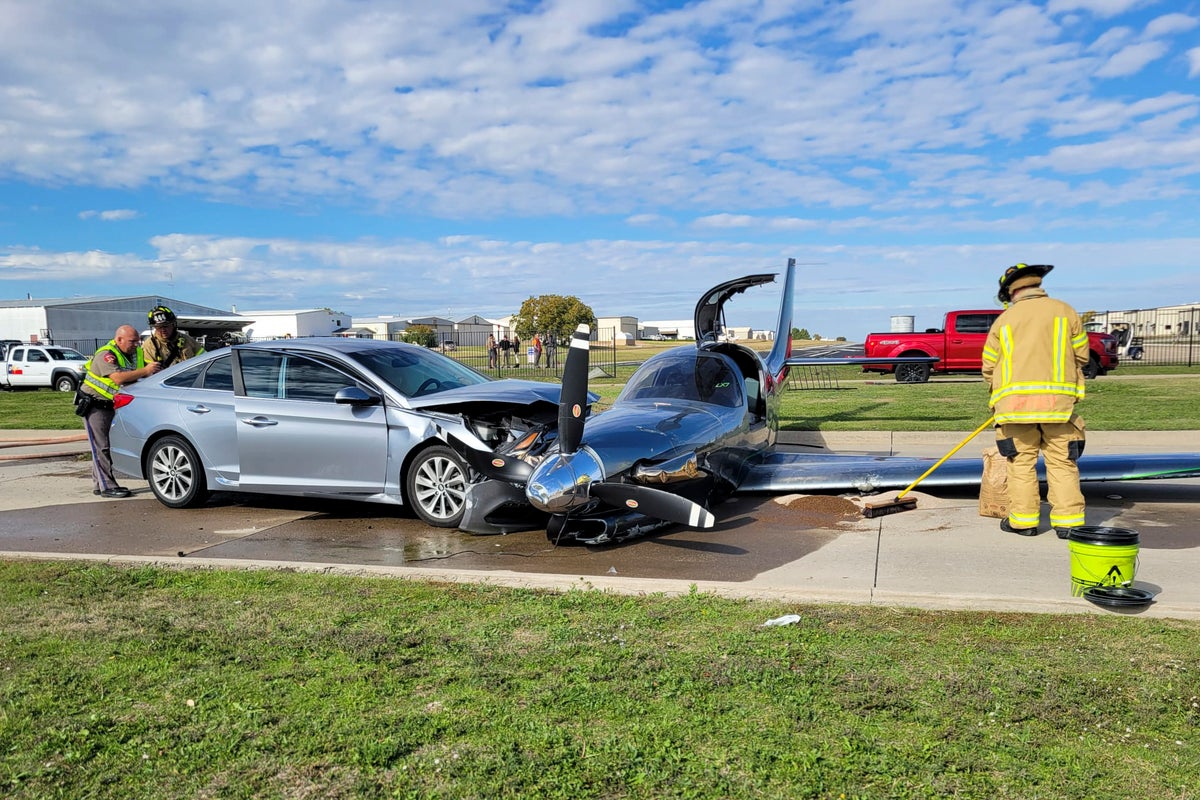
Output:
[{"xmin": 0, "ymin": 431, "xmax": 1200, "ymax": 619}]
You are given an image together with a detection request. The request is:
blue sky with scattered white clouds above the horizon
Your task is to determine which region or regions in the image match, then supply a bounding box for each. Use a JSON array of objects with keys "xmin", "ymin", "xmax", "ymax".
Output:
[{"xmin": 0, "ymin": 0, "xmax": 1200, "ymax": 339}]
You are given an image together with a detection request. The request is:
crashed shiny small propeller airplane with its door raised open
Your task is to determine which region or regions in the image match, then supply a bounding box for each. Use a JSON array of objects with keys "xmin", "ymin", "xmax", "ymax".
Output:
[{"xmin": 460, "ymin": 259, "xmax": 1200, "ymax": 545}]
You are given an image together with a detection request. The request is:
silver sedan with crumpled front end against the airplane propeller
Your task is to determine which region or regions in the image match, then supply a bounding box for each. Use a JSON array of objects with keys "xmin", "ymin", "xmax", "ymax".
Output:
[{"xmin": 112, "ymin": 338, "xmax": 571, "ymax": 533}]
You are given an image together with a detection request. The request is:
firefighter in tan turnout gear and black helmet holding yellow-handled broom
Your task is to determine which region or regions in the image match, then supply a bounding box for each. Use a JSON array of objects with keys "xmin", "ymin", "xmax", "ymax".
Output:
[{"xmin": 983, "ymin": 264, "xmax": 1088, "ymax": 539}]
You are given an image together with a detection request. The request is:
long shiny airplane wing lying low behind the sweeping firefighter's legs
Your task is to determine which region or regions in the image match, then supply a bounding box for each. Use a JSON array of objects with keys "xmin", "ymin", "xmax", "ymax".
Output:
[{"xmin": 738, "ymin": 451, "xmax": 1200, "ymax": 494}]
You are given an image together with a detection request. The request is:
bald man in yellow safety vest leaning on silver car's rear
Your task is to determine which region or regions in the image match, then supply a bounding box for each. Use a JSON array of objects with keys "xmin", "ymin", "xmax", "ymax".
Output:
[{"xmin": 77, "ymin": 325, "xmax": 162, "ymax": 498}]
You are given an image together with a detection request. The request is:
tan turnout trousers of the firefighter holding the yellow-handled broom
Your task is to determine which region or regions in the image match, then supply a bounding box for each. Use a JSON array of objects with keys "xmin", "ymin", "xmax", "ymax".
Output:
[{"xmin": 996, "ymin": 416, "xmax": 1085, "ymax": 528}]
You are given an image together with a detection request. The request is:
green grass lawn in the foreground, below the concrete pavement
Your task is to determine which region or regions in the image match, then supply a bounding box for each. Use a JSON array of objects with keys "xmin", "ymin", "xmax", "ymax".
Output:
[{"xmin": 0, "ymin": 563, "xmax": 1200, "ymax": 800}]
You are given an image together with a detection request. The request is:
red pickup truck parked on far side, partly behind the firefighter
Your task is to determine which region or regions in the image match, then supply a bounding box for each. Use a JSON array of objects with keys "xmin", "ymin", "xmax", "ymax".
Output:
[{"xmin": 863, "ymin": 308, "xmax": 1117, "ymax": 384}]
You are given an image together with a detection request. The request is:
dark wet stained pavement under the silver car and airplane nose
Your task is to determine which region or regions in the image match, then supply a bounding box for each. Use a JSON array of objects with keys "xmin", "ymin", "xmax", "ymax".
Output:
[{"xmin": 0, "ymin": 465, "xmax": 871, "ymax": 581}]
